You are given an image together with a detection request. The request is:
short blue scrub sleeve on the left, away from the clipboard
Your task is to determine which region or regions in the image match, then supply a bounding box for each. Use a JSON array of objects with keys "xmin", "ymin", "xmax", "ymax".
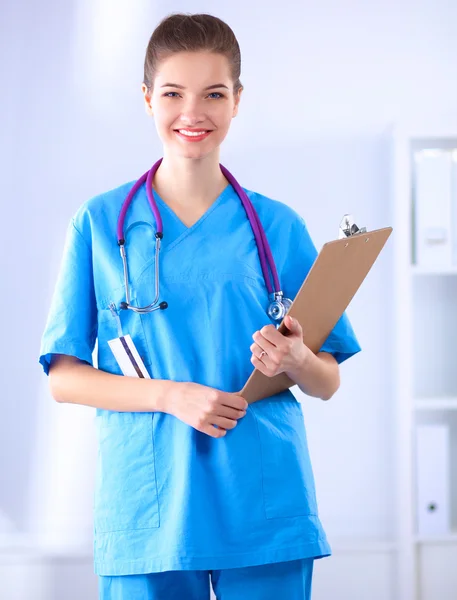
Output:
[{"xmin": 39, "ymin": 219, "xmax": 97, "ymax": 375}]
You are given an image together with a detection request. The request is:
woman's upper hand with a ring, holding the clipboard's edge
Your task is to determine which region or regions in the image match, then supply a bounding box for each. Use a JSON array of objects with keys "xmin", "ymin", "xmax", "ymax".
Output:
[{"xmin": 250, "ymin": 315, "xmax": 313, "ymax": 377}]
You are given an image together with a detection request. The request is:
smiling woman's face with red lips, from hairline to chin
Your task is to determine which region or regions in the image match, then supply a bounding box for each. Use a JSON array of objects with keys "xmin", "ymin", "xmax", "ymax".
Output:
[{"xmin": 142, "ymin": 52, "xmax": 242, "ymax": 158}]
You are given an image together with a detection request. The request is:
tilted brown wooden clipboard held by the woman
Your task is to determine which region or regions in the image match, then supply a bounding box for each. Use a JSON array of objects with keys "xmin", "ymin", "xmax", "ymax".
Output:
[{"xmin": 238, "ymin": 227, "xmax": 392, "ymax": 404}]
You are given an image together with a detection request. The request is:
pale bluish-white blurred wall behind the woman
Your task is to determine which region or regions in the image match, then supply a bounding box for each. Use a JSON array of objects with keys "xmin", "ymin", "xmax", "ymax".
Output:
[{"xmin": 0, "ymin": 0, "xmax": 457, "ymax": 600}]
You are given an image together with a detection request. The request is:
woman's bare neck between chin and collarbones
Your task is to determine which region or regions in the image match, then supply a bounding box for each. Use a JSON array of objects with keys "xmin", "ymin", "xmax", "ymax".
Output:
[{"xmin": 154, "ymin": 152, "xmax": 228, "ymax": 209}]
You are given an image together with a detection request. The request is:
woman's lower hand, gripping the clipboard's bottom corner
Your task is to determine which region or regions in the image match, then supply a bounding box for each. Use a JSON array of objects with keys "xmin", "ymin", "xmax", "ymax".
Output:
[{"xmin": 166, "ymin": 382, "xmax": 248, "ymax": 438}]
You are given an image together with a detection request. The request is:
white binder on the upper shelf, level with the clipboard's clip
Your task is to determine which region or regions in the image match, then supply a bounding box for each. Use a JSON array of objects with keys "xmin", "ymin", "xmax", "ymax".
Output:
[{"xmin": 414, "ymin": 148, "xmax": 457, "ymax": 268}]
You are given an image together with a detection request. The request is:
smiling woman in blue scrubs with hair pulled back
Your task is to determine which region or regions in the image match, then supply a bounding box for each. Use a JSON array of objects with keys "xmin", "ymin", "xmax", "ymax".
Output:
[{"xmin": 40, "ymin": 14, "xmax": 360, "ymax": 600}]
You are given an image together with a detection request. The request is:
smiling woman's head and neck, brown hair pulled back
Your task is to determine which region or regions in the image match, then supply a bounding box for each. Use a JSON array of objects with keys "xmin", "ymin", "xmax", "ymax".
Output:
[{"xmin": 142, "ymin": 14, "xmax": 243, "ymax": 212}]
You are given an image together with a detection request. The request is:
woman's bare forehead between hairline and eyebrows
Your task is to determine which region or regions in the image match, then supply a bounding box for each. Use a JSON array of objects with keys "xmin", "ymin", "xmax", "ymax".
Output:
[{"xmin": 155, "ymin": 52, "xmax": 231, "ymax": 88}]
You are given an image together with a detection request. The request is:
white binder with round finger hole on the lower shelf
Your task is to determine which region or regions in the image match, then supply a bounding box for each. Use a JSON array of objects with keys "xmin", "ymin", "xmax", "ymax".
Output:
[{"xmin": 416, "ymin": 424, "xmax": 451, "ymax": 536}]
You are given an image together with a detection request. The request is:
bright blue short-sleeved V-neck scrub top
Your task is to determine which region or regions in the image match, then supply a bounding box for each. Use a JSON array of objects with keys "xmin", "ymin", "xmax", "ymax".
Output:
[{"xmin": 40, "ymin": 177, "xmax": 360, "ymax": 575}]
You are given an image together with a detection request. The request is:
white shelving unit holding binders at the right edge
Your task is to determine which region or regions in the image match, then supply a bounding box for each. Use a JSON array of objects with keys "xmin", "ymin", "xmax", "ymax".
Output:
[{"xmin": 392, "ymin": 124, "xmax": 457, "ymax": 600}]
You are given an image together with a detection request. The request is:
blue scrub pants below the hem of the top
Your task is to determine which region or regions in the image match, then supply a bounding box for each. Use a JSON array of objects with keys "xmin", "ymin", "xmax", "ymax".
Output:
[{"xmin": 99, "ymin": 558, "xmax": 314, "ymax": 600}]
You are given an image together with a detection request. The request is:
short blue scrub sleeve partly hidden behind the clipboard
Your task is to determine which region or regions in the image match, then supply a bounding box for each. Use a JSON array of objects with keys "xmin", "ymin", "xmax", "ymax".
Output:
[{"xmin": 282, "ymin": 217, "xmax": 361, "ymax": 364}]
